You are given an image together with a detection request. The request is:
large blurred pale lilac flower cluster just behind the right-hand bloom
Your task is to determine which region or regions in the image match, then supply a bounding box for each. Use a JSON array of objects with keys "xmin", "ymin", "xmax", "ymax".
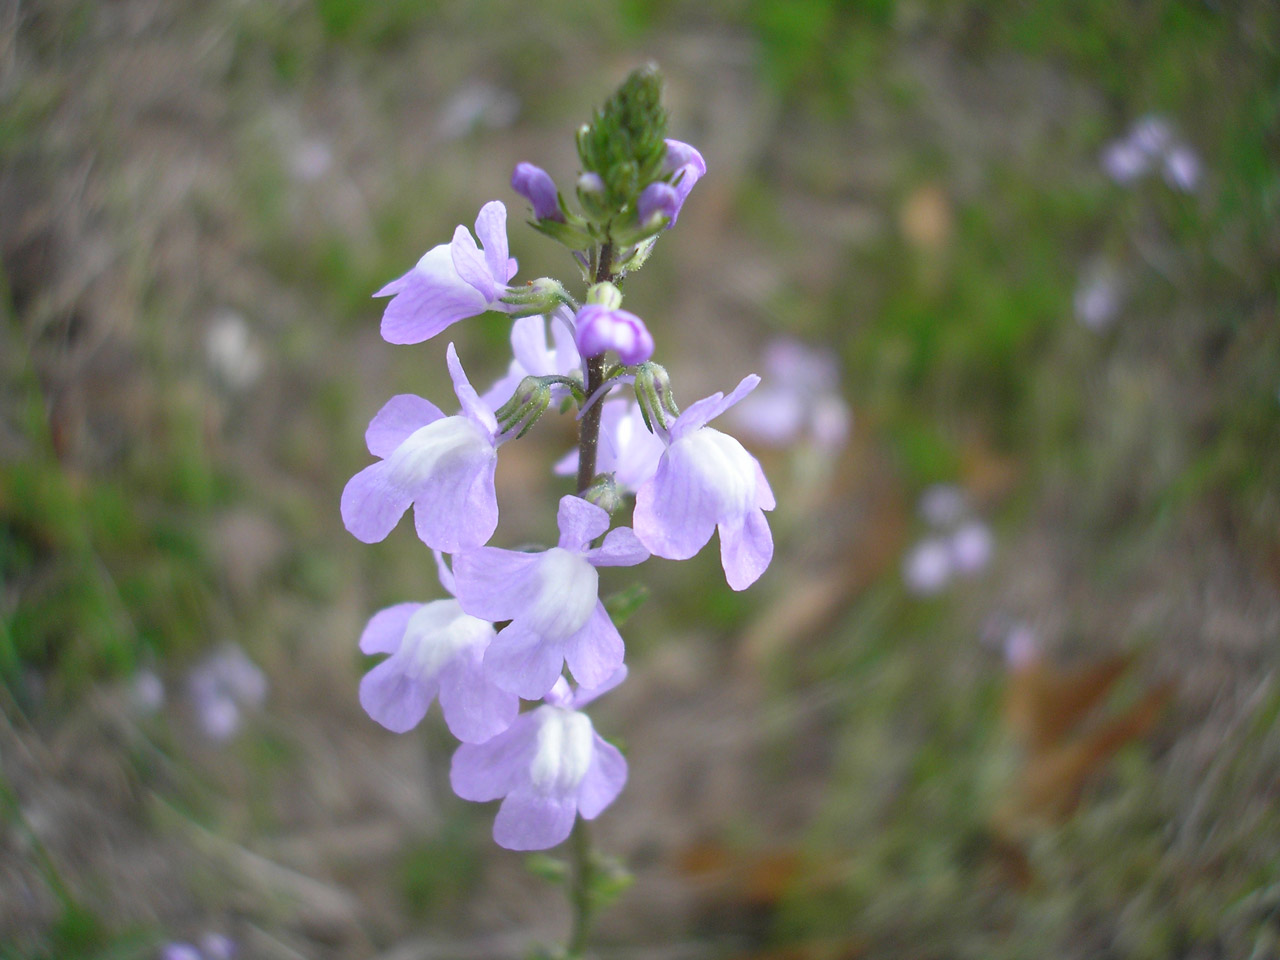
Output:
[{"xmin": 732, "ymin": 338, "xmax": 850, "ymax": 449}]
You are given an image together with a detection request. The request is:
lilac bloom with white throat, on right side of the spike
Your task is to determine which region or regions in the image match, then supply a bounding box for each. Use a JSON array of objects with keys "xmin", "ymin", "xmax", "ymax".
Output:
[{"xmin": 632, "ymin": 374, "xmax": 776, "ymax": 590}]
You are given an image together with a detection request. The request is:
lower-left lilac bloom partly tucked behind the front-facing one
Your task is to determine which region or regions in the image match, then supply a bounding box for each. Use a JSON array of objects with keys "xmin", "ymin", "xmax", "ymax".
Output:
[{"xmin": 360, "ymin": 553, "xmax": 520, "ymax": 742}]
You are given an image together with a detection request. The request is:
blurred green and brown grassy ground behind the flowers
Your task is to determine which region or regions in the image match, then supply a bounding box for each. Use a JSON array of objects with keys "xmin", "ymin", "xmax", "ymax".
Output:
[{"xmin": 0, "ymin": 0, "xmax": 1280, "ymax": 960}]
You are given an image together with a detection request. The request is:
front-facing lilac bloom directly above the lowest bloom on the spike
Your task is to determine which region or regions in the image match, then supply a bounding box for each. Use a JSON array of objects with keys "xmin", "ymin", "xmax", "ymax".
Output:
[{"xmin": 453, "ymin": 497, "xmax": 649, "ymax": 700}]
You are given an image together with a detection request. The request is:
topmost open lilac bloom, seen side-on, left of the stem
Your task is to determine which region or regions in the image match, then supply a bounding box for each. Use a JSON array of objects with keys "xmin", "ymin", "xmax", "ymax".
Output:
[{"xmin": 374, "ymin": 200, "xmax": 516, "ymax": 343}]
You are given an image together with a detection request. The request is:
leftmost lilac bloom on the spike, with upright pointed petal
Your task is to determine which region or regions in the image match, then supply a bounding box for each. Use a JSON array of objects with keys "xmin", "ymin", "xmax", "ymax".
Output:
[{"xmin": 342, "ymin": 343, "xmax": 500, "ymax": 553}]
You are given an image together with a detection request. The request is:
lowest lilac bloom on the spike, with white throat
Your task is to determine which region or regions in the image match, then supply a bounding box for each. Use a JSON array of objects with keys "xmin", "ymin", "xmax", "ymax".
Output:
[{"xmin": 449, "ymin": 667, "xmax": 627, "ymax": 850}]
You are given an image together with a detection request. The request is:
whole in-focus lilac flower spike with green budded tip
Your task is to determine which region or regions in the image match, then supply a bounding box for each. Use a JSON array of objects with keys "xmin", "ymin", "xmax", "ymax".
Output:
[{"xmin": 340, "ymin": 72, "xmax": 774, "ymax": 850}]
